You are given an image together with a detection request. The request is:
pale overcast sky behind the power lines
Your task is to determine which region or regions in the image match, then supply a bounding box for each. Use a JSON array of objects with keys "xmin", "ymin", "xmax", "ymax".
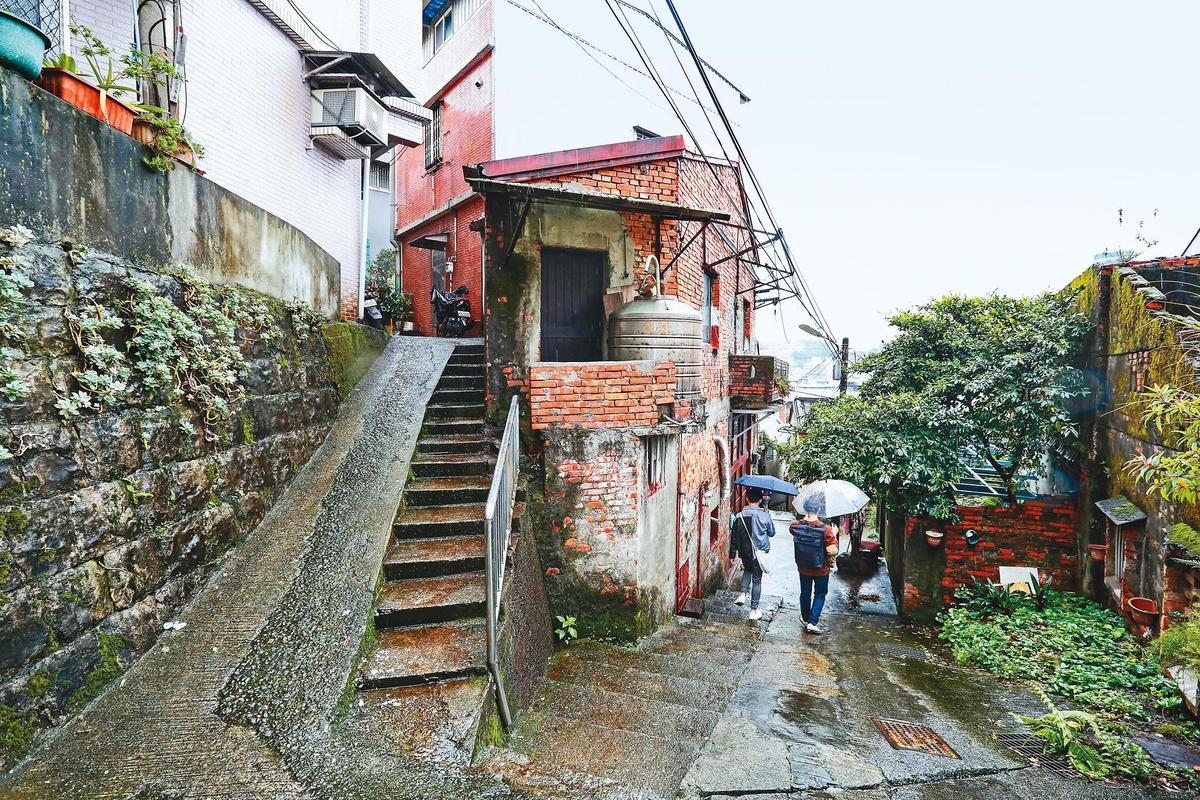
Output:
[{"xmin": 494, "ymin": 0, "xmax": 1200, "ymax": 349}]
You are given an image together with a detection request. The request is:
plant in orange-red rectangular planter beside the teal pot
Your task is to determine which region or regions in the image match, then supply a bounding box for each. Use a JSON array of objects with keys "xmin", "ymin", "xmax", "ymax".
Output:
[{"xmin": 38, "ymin": 24, "xmax": 136, "ymax": 133}]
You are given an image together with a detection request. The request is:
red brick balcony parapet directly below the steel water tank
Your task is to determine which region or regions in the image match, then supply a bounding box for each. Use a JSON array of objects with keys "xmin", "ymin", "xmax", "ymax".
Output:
[{"xmin": 529, "ymin": 361, "xmax": 676, "ymax": 431}]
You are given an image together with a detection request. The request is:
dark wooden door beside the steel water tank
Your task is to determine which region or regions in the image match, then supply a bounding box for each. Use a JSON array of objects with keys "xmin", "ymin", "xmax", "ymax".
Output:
[{"xmin": 541, "ymin": 249, "xmax": 605, "ymax": 361}]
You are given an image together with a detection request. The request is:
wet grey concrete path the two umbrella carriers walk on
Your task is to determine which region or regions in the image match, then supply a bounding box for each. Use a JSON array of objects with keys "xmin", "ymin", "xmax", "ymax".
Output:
[{"xmin": 682, "ymin": 515, "xmax": 1178, "ymax": 800}]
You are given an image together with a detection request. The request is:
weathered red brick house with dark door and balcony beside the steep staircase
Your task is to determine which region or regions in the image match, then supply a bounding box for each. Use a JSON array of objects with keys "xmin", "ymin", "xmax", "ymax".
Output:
[{"xmin": 467, "ymin": 136, "xmax": 779, "ymax": 636}]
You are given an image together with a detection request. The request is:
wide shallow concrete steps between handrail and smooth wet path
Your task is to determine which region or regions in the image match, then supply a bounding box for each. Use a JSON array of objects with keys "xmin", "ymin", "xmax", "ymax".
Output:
[{"xmin": 484, "ymin": 591, "xmax": 780, "ymax": 800}]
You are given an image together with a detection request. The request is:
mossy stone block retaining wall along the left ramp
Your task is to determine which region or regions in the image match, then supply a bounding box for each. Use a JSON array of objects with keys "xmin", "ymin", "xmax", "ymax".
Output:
[{"xmin": 0, "ymin": 229, "xmax": 384, "ymax": 769}]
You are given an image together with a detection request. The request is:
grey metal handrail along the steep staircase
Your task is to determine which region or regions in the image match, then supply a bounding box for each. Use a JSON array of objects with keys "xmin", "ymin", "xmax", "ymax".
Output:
[{"xmin": 484, "ymin": 397, "xmax": 521, "ymax": 730}]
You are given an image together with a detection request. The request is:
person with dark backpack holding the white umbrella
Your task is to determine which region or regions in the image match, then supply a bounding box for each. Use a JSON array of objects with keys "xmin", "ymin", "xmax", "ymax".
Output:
[{"xmin": 788, "ymin": 481, "xmax": 870, "ymax": 634}]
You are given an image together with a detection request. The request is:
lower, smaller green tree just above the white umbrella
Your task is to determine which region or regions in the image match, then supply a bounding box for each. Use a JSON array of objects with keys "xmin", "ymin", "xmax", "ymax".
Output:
[{"xmin": 780, "ymin": 392, "xmax": 962, "ymax": 519}]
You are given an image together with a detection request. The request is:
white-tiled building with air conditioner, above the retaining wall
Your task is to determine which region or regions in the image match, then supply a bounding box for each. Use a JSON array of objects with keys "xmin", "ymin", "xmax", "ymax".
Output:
[{"xmin": 55, "ymin": 0, "xmax": 428, "ymax": 319}]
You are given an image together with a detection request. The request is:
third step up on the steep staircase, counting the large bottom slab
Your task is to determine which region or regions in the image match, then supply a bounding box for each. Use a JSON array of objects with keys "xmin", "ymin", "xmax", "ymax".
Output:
[{"xmin": 376, "ymin": 572, "xmax": 487, "ymax": 630}]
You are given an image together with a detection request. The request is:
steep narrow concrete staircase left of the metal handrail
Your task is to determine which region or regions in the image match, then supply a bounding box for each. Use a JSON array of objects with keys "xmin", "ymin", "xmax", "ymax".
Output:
[{"xmin": 359, "ymin": 341, "xmax": 496, "ymax": 763}]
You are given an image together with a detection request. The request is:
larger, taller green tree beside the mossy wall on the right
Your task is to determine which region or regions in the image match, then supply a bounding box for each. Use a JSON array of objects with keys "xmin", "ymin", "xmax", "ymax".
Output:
[{"xmin": 856, "ymin": 293, "xmax": 1088, "ymax": 504}]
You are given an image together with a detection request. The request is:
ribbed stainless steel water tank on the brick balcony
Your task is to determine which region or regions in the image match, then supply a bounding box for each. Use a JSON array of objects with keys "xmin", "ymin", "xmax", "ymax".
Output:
[{"xmin": 608, "ymin": 295, "xmax": 704, "ymax": 397}]
